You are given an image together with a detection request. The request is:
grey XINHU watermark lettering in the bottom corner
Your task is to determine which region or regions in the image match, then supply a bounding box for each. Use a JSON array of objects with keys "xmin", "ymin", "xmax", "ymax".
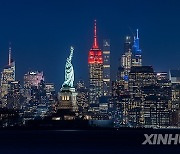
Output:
[{"xmin": 142, "ymin": 134, "xmax": 180, "ymax": 145}]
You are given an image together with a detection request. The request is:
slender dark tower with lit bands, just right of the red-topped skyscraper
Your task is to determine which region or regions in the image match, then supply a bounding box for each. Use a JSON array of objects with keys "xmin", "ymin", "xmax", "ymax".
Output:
[{"xmin": 103, "ymin": 40, "xmax": 111, "ymax": 96}]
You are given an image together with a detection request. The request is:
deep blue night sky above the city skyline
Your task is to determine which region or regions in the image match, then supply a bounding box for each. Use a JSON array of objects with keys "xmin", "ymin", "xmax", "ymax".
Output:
[{"xmin": 0, "ymin": 0, "xmax": 180, "ymax": 89}]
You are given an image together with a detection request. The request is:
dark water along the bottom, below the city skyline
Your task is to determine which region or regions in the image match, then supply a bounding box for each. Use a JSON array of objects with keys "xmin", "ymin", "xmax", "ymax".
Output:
[{"xmin": 0, "ymin": 130, "xmax": 180, "ymax": 154}]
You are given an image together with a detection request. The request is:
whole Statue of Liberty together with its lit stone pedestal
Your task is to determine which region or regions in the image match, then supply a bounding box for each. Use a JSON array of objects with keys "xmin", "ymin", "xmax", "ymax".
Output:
[{"xmin": 57, "ymin": 47, "xmax": 78, "ymax": 120}]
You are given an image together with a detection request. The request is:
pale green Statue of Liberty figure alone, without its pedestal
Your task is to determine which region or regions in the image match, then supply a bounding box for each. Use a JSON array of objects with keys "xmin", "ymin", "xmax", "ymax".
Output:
[{"xmin": 62, "ymin": 46, "xmax": 74, "ymax": 88}]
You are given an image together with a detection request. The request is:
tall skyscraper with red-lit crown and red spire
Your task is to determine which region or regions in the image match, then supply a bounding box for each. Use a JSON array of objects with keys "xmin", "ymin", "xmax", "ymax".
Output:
[{"xmin": 88, "ymin": 20, "xmax": 103, "ymax": 107}]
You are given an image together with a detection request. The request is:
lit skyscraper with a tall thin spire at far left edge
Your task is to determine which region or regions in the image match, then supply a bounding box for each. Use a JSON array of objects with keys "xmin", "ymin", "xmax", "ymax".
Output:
[{"xmin": 1, "ymin": 46, "xmax": 15, "ymax": 107}]
